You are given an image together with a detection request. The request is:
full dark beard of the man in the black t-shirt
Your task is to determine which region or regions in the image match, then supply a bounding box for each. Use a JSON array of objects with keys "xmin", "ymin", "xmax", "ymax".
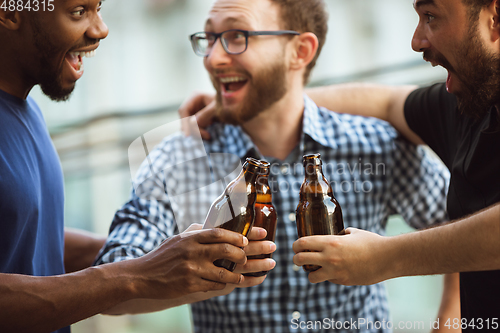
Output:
[{"xmin": 424, "ymin": 22, "xmax": 500, "ymax": 118}]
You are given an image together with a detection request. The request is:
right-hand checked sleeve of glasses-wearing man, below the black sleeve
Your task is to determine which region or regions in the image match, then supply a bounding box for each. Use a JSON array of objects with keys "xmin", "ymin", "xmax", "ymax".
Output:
[{"xmin": 388, "ymin": 139, "xmax": 450, "ymax": 229}]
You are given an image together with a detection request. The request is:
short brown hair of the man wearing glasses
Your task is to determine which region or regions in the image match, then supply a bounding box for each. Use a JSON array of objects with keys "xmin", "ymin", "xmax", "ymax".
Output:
[{"xmin": 271, "ymin": 0, "xmax": 328, "ymax": 83}]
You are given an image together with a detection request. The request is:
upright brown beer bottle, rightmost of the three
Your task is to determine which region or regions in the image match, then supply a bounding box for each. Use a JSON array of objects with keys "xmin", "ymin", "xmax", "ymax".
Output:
[{"xmin": 296, "ymin": 154, "xmax": 345, "ymax": 272}]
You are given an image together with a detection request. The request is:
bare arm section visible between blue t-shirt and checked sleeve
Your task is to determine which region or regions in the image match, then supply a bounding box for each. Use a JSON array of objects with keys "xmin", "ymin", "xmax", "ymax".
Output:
[{"xmin": 64, "ymin": 228, "xmax": 106, "ymax": 273}]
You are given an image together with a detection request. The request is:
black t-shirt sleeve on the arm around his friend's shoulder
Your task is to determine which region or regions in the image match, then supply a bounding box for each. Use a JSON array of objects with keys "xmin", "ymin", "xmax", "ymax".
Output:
[{"xmin": 404, "ymin": 83, "xmax": 458, "ymax": 168}]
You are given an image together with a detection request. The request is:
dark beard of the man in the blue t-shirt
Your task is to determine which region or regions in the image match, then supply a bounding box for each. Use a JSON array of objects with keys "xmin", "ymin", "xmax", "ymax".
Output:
[{"xmin": 32, "ymin": 18, "xmax": 75, "ymax": 102}]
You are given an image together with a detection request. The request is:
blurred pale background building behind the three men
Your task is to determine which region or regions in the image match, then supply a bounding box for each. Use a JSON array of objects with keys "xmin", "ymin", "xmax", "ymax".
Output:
[{"xmin": 32, "ymin": 0, "xmax": 446, "ymax": 333}]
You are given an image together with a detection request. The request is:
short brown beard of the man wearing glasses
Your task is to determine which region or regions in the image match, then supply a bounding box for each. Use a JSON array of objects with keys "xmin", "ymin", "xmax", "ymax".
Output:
[{"xmin": 211, "ymin": 62, "xmax": 287, "ymax": 125}]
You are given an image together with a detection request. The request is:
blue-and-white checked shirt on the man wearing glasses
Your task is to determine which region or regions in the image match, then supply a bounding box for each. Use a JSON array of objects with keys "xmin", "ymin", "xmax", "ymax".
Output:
[{"xmin": 96, "ymin": 96, "xmax": 449, "ymax": 333}]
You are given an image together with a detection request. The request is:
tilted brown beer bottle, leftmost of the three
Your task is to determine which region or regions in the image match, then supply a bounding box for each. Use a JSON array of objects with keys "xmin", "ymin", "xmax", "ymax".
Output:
[{"xmin": 203, "ymin": 158, "xmax": 261, "ymax": 272}]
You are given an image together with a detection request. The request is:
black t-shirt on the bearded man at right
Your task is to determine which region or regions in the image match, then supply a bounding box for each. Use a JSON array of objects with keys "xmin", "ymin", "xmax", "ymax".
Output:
[{"xmin": 405, "ymin": 84, "xmax": 500, "ymax": 326}]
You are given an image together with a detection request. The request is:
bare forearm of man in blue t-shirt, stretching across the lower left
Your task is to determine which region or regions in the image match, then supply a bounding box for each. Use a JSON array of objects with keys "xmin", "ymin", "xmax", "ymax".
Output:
[{"xmin": 0, "ymin": 265, "xmax": 133, "ymax": 333}]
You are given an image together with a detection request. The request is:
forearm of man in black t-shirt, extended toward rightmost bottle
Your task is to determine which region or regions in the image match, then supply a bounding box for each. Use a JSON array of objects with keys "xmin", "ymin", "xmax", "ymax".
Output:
[{"xmin": 385, "ymin": 205, "xmax": 500, "ymax": 278}]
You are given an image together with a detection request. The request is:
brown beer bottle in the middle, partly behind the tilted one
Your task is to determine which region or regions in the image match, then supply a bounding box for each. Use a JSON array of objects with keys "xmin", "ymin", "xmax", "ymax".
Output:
[{"xmin": 243, "ymin": 161, "xmax": 278, "ymax": 277}]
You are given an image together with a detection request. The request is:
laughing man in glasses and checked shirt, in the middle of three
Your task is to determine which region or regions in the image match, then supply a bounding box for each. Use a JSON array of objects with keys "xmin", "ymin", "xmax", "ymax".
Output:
[{"xmin": 96, "ymin": 0, "xmax": 458, "ymax": 333}]
